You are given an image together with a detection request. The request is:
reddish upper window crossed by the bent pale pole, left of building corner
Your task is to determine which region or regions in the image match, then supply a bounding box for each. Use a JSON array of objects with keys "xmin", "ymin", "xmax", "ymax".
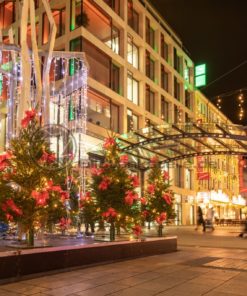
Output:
[{"xmin": 42, "ymin": 7, "xmax": 65, "ymax": 44}]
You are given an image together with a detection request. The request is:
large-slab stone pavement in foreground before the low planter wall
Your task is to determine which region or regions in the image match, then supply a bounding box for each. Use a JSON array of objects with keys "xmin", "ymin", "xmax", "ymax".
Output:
[{"xmin": 0, "ymin": 247, "xmax": 247, "ymax": 296}]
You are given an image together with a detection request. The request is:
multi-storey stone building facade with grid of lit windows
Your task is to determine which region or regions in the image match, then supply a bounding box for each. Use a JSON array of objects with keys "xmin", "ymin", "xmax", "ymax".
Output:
[{"xmin": 0, "ymin": 0, "xmax": 245, "ymax": 224}]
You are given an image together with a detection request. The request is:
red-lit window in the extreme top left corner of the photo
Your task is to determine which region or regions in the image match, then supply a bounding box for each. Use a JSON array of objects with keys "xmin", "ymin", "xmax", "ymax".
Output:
[{"xmin": 0, "ymin": 1, "xmax": 15, "ymax": 29}]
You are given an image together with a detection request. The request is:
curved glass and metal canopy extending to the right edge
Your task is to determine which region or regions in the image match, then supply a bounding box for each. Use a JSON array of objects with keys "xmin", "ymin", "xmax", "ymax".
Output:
[{"xmin": 118, "ymin": 122, "xmax": 247, "ymax": 170}]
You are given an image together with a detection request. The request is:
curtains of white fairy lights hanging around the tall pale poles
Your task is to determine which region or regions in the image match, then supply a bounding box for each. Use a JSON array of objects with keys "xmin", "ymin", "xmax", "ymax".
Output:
[{"xmin": 0, "ymin": 45, "xmax": 88, "ymax": 187}]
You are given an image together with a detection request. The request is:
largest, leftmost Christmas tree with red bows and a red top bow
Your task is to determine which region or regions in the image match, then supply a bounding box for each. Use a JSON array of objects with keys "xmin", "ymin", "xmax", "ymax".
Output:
[{"xmin": 0, "ymin": 110, "xmax": 69, "ymax": 246}]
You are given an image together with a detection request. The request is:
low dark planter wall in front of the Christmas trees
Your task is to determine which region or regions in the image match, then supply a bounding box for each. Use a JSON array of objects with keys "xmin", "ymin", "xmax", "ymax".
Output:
[{"xmin": 0, "ymin": 237, "xmax": 177, "ymax": 283}]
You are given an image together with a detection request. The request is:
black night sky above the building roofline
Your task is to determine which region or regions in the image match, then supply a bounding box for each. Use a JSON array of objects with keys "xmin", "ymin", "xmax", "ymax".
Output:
[{"xmin": 150, "ymin": 0, "xmax": 247, "ymax": 125}]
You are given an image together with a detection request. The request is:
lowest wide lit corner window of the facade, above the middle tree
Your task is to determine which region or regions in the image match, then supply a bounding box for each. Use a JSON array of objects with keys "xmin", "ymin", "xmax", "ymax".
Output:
[{"xmin": 88, "ymin": 89, "xmax": 119, "ymax": 132}]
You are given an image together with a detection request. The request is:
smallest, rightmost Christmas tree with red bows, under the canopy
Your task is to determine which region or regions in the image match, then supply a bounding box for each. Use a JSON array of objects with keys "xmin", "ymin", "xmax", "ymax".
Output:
[{"xmin": 142, "ymin": 157, "xmax": 174, "ymax": 236}]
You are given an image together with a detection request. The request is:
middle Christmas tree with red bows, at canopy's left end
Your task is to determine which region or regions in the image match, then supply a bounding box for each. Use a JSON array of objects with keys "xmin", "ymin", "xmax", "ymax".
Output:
[{"xmin": 91, "ymin": 138, "xmax": 141, "ymax": 241}]
